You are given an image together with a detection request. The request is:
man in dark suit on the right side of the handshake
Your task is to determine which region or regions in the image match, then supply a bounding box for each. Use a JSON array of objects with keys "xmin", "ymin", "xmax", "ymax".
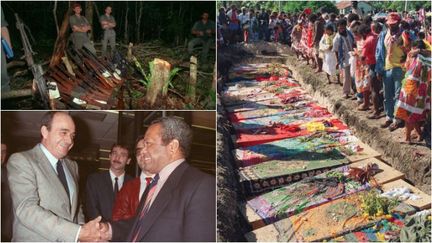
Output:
[{"xmin": 102, "ymin": 117, "xmax": 216, "ymax": 242}]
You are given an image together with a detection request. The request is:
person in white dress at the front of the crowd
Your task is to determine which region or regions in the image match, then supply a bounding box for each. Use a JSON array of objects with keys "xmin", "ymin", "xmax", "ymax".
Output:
[{"xmin": 319, "ymin": 24, "xmax": 341, "ymax": 84}]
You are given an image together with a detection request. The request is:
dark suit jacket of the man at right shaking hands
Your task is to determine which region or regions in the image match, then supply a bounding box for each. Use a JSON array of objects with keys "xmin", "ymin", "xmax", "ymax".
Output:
[{"xmin": 111, "ymin": 162, "xmax": 216, "ymax": 242}]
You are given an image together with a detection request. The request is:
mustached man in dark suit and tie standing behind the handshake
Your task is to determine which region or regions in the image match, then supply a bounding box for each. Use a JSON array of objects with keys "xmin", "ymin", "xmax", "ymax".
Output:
[{"xmin": 85, "ymin": 144, "xmax": 132, "ymax": 221}]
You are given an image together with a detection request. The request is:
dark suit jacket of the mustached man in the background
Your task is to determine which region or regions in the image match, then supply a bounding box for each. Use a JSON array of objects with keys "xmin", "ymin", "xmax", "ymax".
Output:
[{"xmin": 85, "ymin": 171, "xmax": 132, "ymax": 221}]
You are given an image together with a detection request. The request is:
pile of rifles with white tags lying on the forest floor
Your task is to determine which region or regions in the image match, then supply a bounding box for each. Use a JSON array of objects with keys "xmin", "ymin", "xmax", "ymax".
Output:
[{"xmin": 44, "ymin": 48, "xmax": 126, "ymax": 109}]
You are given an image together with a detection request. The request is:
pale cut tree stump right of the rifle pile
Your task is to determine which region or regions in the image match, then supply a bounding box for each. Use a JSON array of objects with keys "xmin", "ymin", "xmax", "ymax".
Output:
[{"xmin": 146, "ymin": 58, "xmax": 171, "ymax": 106}]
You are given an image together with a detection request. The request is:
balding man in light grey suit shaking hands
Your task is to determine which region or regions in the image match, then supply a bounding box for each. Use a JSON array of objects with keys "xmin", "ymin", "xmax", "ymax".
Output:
[{"xmin": 7, "ymin": 112, "xmax": 101, "ymax": 242}]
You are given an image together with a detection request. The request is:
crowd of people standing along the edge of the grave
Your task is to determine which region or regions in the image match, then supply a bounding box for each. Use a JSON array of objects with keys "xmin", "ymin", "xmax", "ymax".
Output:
[{"xmin": 217, "ymin": 1, "xmax": 432, "ymax": 147}]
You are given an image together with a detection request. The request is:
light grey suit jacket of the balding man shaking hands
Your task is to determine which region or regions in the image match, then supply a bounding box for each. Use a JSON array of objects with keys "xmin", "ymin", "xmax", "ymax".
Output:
[{"xmin": 7, "ymin": 145, "xmax": 84, "ymax": 241}]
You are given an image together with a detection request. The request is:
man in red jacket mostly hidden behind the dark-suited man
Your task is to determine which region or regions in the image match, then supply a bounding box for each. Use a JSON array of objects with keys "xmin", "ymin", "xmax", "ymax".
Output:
[{"xmin": 112, "ymin": 135, "xmax": 155, "ymax": 221}]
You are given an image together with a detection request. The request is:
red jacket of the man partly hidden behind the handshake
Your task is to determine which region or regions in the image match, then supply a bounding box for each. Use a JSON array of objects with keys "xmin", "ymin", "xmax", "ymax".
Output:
[{"xmin": 112, "ymin": 177, "xmax": 141, "ymax": 221}]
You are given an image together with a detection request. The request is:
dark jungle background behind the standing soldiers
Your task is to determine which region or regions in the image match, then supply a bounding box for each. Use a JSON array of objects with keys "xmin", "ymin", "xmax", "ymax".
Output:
[{"xmin": 1, "ymin": 1, "xmax": 216, "ymax": 109}]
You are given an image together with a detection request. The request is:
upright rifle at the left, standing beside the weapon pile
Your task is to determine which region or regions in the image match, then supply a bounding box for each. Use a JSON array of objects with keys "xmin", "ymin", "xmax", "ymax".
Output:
[{"xmin": 15, "ymin": 13, "xmax": 54, "ymax": 109}]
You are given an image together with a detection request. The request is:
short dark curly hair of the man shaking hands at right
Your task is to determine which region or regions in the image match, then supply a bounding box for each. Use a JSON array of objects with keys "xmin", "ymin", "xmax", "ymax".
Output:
[{"xmin": 151, "ymin": 116, "xmax": 192, "ymax": 157}]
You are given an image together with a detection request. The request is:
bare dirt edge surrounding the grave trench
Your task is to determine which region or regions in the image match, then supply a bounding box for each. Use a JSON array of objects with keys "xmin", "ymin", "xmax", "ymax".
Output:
[{"xmin": 217, "ymin": 42, "xmax": 431, "ymax": 240}]
